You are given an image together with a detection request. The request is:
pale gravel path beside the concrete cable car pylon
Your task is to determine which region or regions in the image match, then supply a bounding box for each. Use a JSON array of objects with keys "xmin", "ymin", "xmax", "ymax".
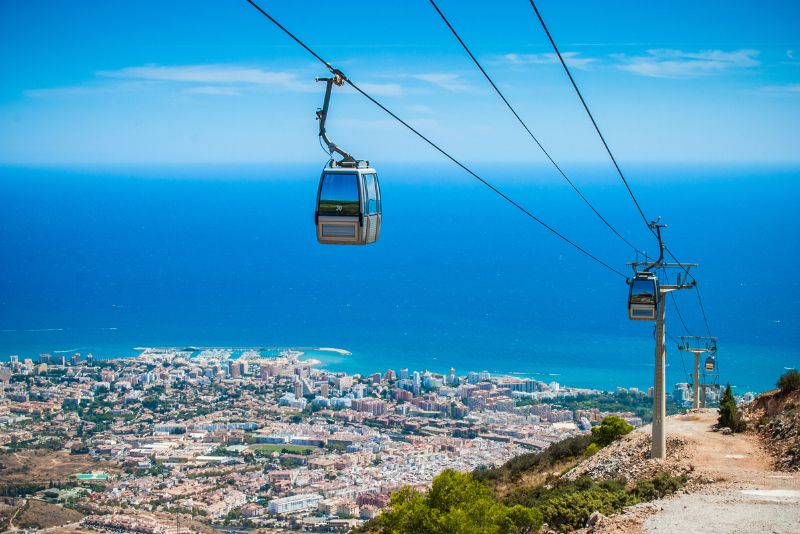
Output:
[{"xmin": 587, "ymin": 410, "xmax": 800, "ymax": 534}]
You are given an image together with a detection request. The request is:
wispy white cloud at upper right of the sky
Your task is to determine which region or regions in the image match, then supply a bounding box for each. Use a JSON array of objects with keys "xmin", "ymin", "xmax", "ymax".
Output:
[{"xmin": 613, "ymin": 49, "xmax": 761, "ymax": 78}]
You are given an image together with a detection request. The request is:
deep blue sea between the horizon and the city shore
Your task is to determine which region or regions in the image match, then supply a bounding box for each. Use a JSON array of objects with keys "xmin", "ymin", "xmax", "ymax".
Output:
[{"xmin": 0, "ymin": 163, "xmax": 800, "ymax": 393}]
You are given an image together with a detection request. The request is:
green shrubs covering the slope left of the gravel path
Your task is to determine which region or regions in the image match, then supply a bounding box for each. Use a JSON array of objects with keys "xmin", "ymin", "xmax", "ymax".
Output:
[{"xmin": 361, "ymin": 416, "xmax": 686, "ymax": 534}]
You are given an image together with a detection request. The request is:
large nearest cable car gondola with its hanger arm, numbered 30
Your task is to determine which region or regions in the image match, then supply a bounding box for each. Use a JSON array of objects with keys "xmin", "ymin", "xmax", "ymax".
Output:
[{"xmin": 314, "ymin": 70, "xmax": 382, "ymax": 245}]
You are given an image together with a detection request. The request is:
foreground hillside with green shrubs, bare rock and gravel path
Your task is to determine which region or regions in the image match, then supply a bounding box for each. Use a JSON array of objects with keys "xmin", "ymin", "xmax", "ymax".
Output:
[{"xmin": 362, "ymin": 382, "xmax": 800, "ymax": 534}]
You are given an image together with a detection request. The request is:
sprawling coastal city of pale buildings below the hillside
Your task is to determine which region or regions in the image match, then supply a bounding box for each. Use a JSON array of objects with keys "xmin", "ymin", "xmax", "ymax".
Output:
[{"xmin": 0, "ymin": 347, "xmax": 736, "ymax": 532}]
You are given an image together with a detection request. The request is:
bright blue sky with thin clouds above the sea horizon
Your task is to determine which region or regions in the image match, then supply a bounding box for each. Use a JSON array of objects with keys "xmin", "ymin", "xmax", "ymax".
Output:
[{"xmin": 0, "ymin": 0, "xmax": 800, "ymax": 165}]
